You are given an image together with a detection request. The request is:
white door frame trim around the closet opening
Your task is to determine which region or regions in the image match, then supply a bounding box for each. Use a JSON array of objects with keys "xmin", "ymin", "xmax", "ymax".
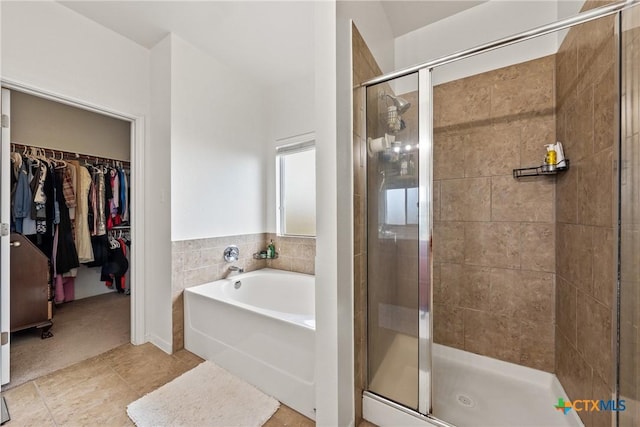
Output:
[{"xmin": 0, "ymin": 78, "xmax": 146, "ymax": 352}]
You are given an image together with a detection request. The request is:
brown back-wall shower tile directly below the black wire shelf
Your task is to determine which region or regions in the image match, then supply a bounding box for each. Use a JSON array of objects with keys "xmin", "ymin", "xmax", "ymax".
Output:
[{"xmin": 491, "ymin": 175, "xmax": 555, "ymax": 223}]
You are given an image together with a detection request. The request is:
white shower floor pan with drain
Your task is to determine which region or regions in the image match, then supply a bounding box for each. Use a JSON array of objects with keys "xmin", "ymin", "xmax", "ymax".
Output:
[{"xmin": 365, "ymin": 334, "xmax": 583, "ymax": 427}]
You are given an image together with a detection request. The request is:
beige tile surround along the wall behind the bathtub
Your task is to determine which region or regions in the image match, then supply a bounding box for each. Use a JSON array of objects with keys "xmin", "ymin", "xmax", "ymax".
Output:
[{"xmin": 171, "ymin": 233, "xmax": 316, "ymax": 352}]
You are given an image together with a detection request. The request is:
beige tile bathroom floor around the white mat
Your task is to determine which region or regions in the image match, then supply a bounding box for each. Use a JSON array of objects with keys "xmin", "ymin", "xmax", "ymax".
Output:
[{"xmin": 2, "ymin": 344, "xmax": 314, "ymax": 427}]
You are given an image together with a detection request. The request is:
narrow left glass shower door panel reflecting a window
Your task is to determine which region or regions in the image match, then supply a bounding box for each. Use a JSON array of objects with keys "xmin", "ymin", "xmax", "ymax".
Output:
[{"xmin": 366, "ymin": 73, "xmax": 431, "ymax": 413}]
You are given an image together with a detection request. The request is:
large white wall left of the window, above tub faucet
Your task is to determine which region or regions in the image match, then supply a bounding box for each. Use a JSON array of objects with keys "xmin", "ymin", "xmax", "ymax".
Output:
[{"xmin": 171, "ymin": 36, "xmax": 269, "ymax": 240}]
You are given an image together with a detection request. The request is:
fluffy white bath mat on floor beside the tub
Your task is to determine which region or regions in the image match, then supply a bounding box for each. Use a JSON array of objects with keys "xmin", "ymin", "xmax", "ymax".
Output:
[{"xmin": 127, "ymin": 361, "xmax": 280, "ymax": 427}]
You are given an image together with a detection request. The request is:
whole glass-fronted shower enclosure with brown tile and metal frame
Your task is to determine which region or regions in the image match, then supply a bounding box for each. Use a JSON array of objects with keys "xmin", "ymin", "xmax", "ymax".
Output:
[{"xmin": 354, "ymin": 2, "xmax": 640, "ymax": 426}]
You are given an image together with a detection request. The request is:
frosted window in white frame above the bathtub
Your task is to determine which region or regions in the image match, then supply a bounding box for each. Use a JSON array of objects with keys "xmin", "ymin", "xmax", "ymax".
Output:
[{"xmin": 276, "ymin": 135, "xmax": 316, "ymax": 237}]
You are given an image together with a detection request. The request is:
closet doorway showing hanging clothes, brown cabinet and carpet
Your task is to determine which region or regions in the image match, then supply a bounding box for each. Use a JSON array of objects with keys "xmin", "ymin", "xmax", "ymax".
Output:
[{"xmin": 2, "ymin": 88, "xmax": 135, "ymax": 389}]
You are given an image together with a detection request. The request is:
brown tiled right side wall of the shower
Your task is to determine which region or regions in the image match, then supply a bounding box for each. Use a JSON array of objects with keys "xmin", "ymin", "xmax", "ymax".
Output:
[{"xmin": 556, "ymin": 2, "xmax": 617, "ymax": 426}]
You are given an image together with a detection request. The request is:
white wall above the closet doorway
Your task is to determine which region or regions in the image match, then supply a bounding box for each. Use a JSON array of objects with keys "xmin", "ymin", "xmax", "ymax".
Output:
[{"xmin": 0, "ymin": 2, "xmax": 149, "ymax": 115}]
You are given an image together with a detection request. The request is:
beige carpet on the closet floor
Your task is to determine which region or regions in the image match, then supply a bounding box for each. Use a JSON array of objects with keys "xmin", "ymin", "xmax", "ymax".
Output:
[{"xmin": 2, "ymin": 292, "xmax": 131, "ymax": 391}]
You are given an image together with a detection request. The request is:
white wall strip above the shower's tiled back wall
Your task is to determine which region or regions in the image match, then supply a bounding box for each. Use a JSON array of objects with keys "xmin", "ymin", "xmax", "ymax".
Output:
[{"xmin": 395, "ymin": 0, "xmax": 558, "ymax": 87}]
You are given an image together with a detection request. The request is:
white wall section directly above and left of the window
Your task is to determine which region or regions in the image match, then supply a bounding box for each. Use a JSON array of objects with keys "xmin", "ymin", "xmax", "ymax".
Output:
[{"xmin": 265, "ymin": 74, "xmax": 315, "ymax": 233}]
